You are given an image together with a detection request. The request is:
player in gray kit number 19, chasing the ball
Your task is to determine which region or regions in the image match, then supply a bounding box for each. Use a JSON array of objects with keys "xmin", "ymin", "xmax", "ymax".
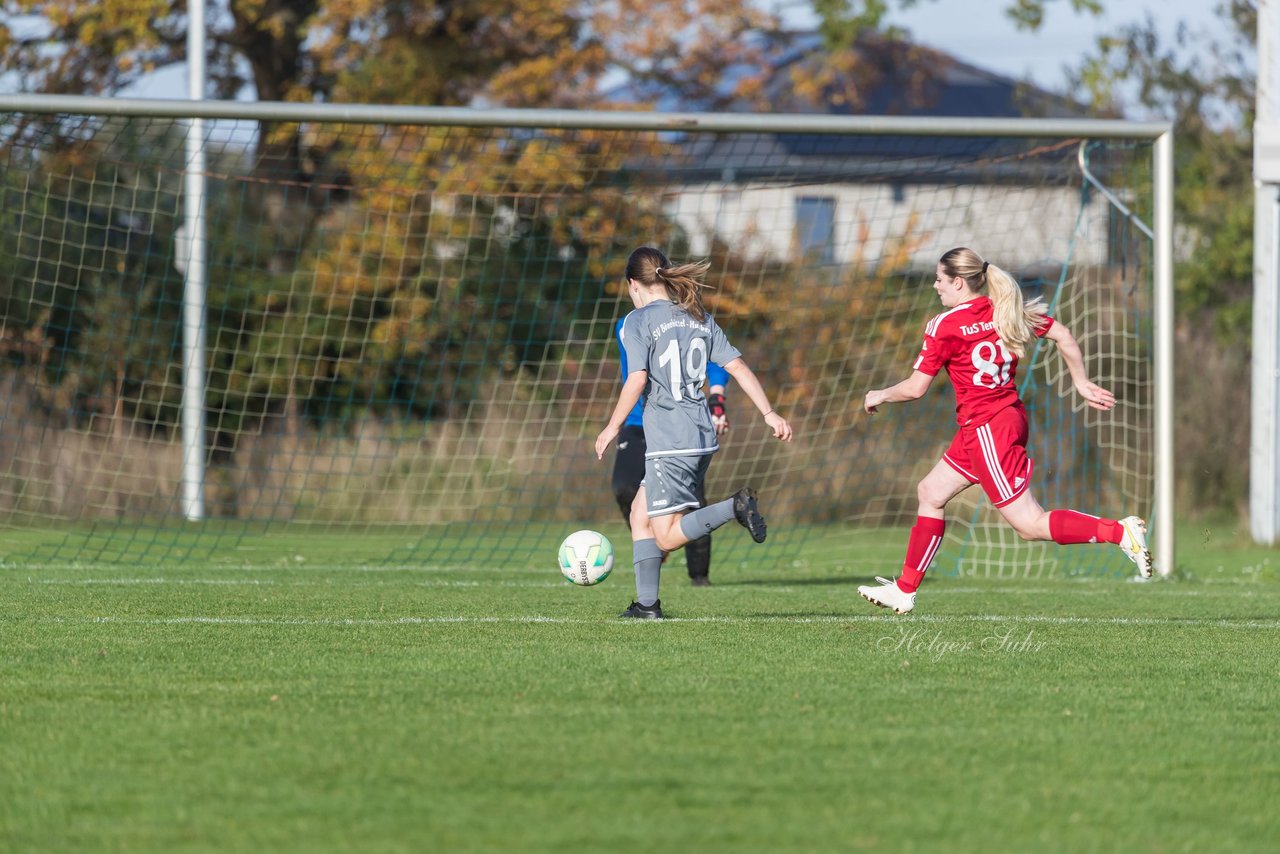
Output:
[{"xmin": 595, "ymin": 246, "xmax": 792, "ymax": 620}]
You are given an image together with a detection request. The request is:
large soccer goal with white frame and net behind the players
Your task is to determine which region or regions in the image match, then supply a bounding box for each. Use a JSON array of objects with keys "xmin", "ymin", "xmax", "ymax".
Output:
[{"xmin": 0, "ymin": 96, "xmax": 1174, "ymax": 575}]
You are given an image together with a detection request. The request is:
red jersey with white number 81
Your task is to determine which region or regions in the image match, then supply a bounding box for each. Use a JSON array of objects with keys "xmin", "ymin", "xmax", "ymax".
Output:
[{"xmin": 915, "ymin": 297, "xmax": 1053, "ymax": 426}]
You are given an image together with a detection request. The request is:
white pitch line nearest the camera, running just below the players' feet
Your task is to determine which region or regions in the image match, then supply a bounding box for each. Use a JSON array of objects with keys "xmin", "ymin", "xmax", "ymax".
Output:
[{"xmin": 12, "ymin": 615, "xmax": 1280, "ymax": 631}]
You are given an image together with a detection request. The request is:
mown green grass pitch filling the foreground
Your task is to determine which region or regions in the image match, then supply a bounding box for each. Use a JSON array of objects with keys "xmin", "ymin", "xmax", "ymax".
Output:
[{"xmin": 0, "ymin": 528, "xmax": 1280, "ymax": 851}]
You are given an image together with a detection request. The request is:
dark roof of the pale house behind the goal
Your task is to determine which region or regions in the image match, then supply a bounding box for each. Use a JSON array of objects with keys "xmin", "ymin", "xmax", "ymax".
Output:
[{"xmin": 614, "ymin": 32, "xmax": 1087, "ymax": 183}]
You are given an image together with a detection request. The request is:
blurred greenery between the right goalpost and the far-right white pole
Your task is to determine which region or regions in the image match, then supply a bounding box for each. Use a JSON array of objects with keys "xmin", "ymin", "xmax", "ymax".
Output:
[{"xmin": 1059, "ymin": 0, "xmax": 1257, "ymax": 515}]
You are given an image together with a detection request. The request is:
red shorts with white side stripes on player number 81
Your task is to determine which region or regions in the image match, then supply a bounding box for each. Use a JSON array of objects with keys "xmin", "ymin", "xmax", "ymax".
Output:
[{"xmin": 942, "ymin": 406, "xmax": 1033, "ymax": 507}]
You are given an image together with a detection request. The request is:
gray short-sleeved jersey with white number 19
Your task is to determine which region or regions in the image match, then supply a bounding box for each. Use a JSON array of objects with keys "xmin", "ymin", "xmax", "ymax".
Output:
[{"xmin": 621, "ymin": 300, "xmax": 742, "ymax": 460}]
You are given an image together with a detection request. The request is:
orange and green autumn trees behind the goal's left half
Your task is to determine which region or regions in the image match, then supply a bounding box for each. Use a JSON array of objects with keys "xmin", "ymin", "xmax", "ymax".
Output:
[{"xmin": 0, "ymin": 0, "xmax": 1177, "ymax": 442}]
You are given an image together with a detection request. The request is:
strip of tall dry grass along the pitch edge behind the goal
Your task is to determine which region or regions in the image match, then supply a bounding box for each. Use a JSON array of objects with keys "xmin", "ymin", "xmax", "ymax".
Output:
[{"xmin": 0, "ymin": 299, "xmax": 1248, "ymax": 535}]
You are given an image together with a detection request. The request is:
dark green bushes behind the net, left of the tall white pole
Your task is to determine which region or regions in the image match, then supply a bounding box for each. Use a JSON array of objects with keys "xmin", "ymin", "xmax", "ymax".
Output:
[{"xmin": 0, "ymin": 122, "xmax": 182, "ymax": 431}]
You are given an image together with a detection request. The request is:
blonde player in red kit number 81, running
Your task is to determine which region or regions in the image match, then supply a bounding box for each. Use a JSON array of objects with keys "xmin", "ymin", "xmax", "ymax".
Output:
[{"xmin": 858, "ymin": 247, "xmax": 1151, "ymax": 613}]
